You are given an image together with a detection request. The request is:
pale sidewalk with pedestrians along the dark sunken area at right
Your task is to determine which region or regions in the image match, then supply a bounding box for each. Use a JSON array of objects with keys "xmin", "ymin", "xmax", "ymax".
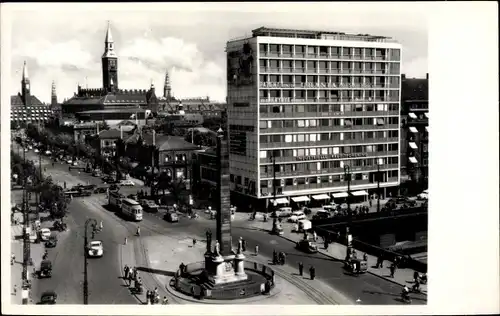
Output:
[{"xmin": 234, "ymin": 213, "xmax": 427, "ymax": 294}]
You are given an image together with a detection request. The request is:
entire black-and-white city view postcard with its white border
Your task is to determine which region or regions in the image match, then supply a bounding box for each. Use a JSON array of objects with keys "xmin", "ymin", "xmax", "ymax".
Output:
[{"xmin": 1, "ymin": 2, "xmax": 500, "ymax": 315}]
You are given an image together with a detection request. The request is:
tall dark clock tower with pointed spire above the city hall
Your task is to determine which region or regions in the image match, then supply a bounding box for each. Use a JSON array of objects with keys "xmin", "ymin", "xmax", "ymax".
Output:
[{"xmin": 102, "ymin": 22, "xmax": 118, "ymax": 92}]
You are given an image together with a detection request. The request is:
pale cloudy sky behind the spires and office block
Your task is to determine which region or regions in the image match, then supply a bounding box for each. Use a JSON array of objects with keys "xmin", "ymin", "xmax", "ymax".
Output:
[{"xmin": 2, "ymin": 2, "xmax": 429, "ymax": 102}]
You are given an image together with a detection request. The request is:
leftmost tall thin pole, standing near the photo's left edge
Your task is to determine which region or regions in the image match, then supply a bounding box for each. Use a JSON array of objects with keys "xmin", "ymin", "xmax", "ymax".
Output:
[{"xmin": 22, "ymin": 150, "xmax": 31, "ymax": 305}]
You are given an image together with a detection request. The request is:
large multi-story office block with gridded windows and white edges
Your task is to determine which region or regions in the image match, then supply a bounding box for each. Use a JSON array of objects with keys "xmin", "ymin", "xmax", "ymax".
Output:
[{"xmin": 226, "ymin": 27, "xmax": 402, "ymax": 207}]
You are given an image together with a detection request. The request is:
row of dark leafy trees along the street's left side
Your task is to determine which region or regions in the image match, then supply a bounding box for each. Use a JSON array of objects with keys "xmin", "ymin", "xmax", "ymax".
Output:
[{"xmin": 11, "ymin": 151, "xmax": 68, "ymax": 218}]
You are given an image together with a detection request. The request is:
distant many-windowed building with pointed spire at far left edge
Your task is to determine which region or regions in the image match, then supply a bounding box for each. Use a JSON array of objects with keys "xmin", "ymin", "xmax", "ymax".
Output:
[{"xmin": 10, "ymin": 62, "xmax": 55, "ymax": 128}]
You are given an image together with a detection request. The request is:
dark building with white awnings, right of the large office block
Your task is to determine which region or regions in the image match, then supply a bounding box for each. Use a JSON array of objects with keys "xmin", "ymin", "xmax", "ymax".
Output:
[{"xmin": 401, "ymin": 74, "xmax": 429, "ymax": 193}]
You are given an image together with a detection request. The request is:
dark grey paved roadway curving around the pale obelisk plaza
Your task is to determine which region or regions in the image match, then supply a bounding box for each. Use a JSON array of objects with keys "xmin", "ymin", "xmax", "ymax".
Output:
[{"xmin": 11, "ymin": 143, "xmax": 426, "ymax": 304}]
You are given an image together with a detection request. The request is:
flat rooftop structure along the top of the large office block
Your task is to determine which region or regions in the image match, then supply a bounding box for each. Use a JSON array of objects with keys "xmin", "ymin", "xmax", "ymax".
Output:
[{"xmin": 234, "ymin": 26, "xmax": 397, "ymax": 43}]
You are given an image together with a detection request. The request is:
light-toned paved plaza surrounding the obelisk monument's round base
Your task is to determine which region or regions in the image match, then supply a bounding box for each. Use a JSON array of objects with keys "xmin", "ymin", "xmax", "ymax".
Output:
[{"xmin": 123, "ymin": 235, "xmax": 352, "ymax": 305}]
